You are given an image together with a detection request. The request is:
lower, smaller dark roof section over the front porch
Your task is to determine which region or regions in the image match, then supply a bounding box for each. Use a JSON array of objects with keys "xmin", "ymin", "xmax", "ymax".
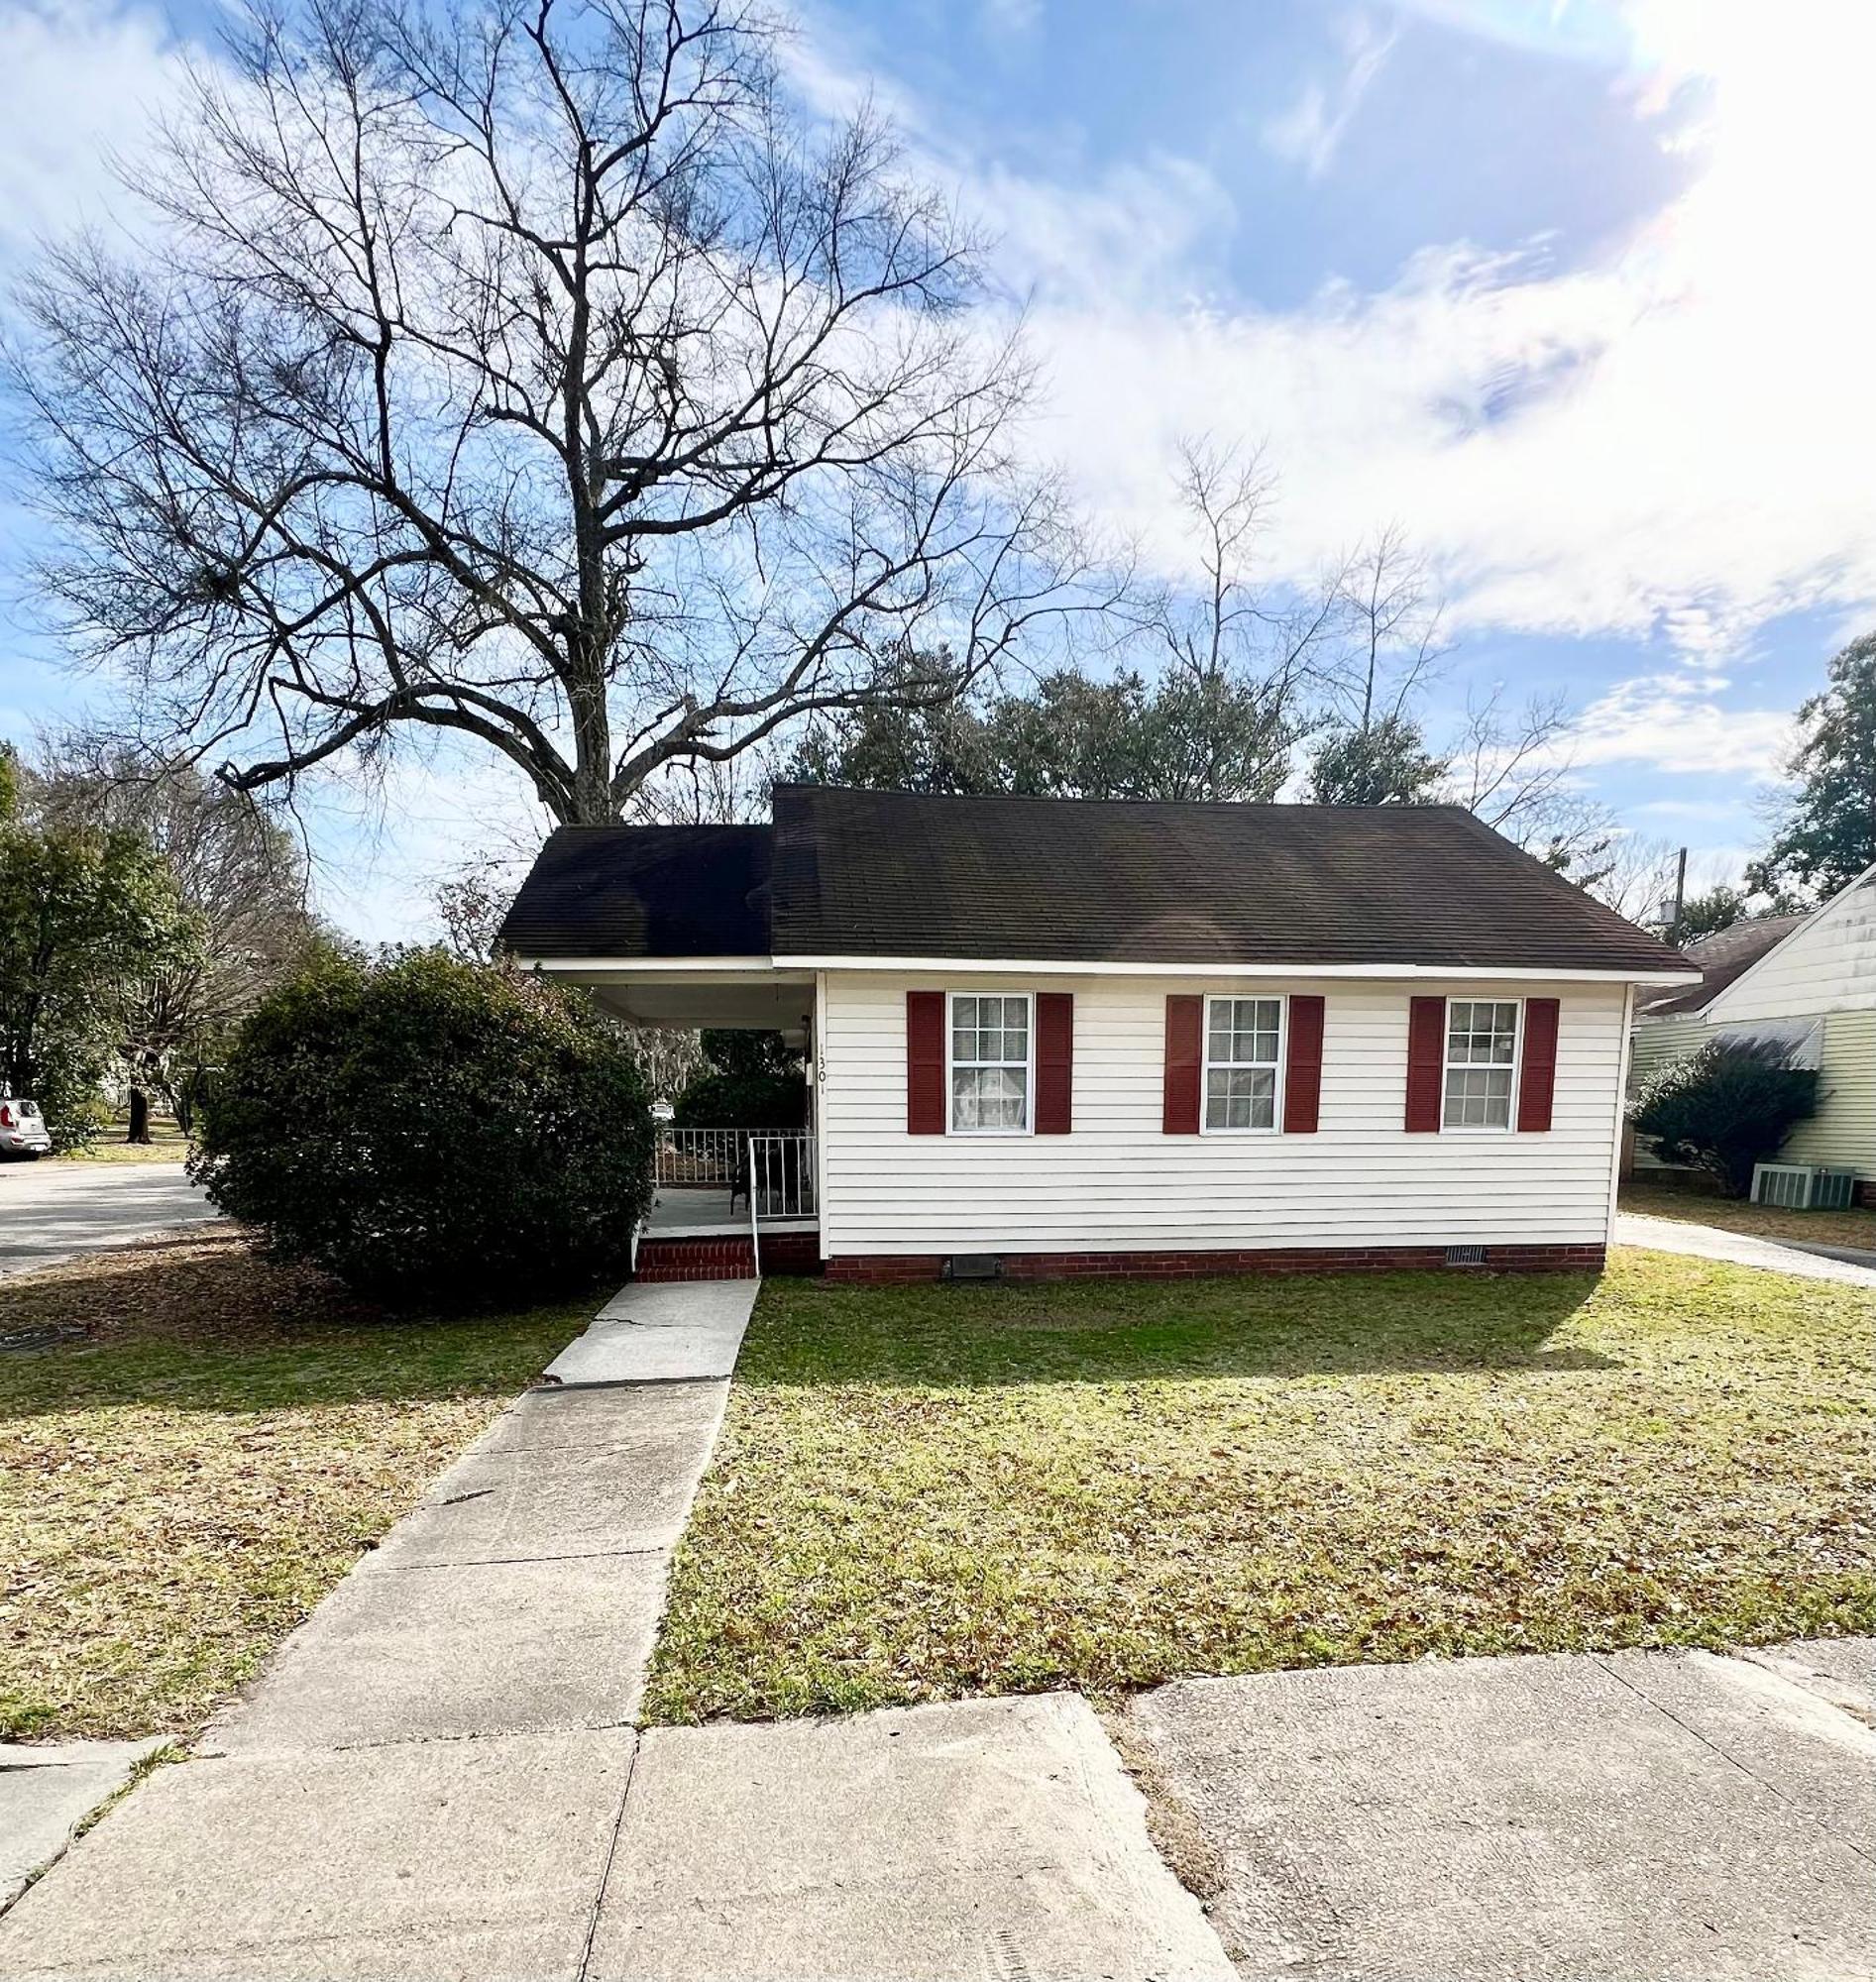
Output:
[{"xmin": 496, "ymin": 826, "xmax": 771, "ymax": 957}]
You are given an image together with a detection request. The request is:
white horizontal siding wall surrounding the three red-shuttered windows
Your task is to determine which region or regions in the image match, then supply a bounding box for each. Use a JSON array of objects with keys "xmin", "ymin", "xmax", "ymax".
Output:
[{"xmin": 821, "ymin": 971, "xmax": 1624, "ymax": 1259}]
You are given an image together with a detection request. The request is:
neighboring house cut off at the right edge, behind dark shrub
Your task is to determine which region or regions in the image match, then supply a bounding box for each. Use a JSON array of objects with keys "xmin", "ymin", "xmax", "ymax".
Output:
[{"xmin": 1634, "ymin": 866, "xmax": 1876, "ymax": 1197}]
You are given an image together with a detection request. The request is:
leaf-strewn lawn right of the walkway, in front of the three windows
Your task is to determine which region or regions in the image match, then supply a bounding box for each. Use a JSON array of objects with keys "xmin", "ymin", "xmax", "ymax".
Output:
[{"xmin": 646, "ymin": 1253, "xmax": 1876, "ymax": 1720}]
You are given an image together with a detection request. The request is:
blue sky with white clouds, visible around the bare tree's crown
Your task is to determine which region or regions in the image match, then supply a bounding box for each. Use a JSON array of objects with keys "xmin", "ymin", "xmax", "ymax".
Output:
[{"xmin": 0, "ymin": 0, "xmax": 1876, "ymax": 937}]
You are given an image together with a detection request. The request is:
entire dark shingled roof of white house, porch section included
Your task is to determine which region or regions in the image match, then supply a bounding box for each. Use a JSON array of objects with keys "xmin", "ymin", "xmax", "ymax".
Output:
[{"xmin": 501, "ymin": 785, "xmax": 1684, "ymax": 973}]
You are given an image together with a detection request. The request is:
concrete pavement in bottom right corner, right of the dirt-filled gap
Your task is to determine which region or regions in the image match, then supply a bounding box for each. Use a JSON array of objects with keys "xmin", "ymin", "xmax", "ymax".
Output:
[{"xmin": 1129, "ymin": 1639, "xmax": 1876, "ymax": 1982}]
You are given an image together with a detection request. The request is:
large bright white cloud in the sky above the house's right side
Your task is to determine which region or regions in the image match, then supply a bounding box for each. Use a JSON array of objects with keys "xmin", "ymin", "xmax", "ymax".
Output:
[{"xmin": 959, "ymin": 8, "xmax": 1876, "ymax": 658}]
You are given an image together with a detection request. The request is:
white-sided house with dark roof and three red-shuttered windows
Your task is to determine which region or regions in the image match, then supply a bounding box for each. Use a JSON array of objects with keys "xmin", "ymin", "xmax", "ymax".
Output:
[{"xmin": 501, "ymin": 785, "xmax": 1692, "ymax": 1278}]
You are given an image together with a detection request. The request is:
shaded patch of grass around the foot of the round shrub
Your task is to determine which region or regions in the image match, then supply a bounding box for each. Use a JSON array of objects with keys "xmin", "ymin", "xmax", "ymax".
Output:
[{"xmin": 0, "ymin": 1227, "xmax": 612, "ymax": 1421}]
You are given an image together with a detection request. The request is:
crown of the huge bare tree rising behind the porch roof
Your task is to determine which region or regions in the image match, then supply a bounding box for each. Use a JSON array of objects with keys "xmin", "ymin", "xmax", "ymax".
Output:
[{"xmin": 12, "ymin": 0, "xmax": 1085, "ymax": 823}]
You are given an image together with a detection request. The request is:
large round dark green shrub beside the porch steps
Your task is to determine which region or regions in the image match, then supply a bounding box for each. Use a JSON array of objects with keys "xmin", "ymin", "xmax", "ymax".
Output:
[{"xmin": 190, "ymin": 951, "xmax": 652, "ymax": 1302}]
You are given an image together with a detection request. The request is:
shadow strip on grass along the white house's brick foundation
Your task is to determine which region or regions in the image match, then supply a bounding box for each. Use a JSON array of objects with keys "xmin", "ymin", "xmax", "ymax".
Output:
[{"xmin": 735, "ymin": 1272, "xmax": 1620, "ymax": 1387}]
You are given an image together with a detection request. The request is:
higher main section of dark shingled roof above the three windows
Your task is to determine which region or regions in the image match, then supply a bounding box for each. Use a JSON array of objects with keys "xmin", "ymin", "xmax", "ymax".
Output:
[{"xmin": 773, "ymin": 785, "xmax": 1680, "ymax": 971}]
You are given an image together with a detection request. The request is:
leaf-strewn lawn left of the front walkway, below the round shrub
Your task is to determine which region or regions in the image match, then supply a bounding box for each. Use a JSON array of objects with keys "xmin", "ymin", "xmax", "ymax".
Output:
[{"xmin": 0, "ymin": 1233, "xmax": 593, "ymax": 1740}]
